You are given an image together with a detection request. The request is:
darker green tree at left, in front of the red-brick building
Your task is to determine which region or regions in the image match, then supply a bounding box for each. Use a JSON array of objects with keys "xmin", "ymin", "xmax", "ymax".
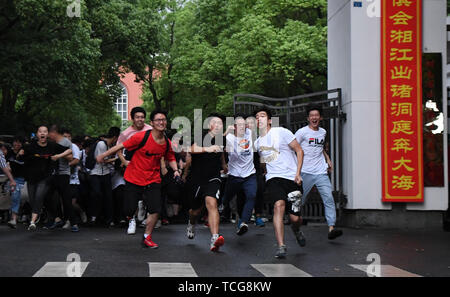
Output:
[{"xmin": 0, "ymin": 0, "xmax": 159, "ymax": 134}]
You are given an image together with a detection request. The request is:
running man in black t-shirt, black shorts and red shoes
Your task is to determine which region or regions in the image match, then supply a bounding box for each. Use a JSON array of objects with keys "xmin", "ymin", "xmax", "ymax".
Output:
[{"xmin": 185, "ymin": 113, "xmax": 227, "ymax": 252}]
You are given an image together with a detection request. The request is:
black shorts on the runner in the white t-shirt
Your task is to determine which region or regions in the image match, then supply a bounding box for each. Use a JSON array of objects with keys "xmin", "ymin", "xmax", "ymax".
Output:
[{"xmin": 266, "ymin": 177, "xmax": 301, "ymax": 216}]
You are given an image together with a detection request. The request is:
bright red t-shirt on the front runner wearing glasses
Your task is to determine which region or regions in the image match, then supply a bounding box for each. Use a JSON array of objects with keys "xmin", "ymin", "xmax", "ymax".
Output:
[{"xmin": 123, "ymin": 131, "xmax": 175, "ymax": 186}]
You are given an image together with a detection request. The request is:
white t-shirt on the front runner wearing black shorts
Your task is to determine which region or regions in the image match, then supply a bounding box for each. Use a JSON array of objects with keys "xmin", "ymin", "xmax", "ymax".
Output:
[{"xmin": 255, "ymin": 127, "xmax": 297, "ymax": 181}]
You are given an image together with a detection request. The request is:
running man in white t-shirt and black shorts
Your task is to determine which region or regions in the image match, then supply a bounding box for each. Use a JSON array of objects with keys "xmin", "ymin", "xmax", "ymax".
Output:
[{"xmin": 255, "ymin": 109, "xmax": 306, "ymax": 258}]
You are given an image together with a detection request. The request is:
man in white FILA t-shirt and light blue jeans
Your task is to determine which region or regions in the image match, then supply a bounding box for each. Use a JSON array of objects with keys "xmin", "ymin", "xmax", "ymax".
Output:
[{"xmin": 295, "ymin": 106, "xmax": 342, "ymax": 239}]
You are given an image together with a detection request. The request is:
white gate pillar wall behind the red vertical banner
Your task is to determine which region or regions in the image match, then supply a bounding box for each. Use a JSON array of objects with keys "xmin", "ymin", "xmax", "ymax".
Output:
[{"xmin": 328, "ymin": 0, "xmax": 448, "ymax": 210}]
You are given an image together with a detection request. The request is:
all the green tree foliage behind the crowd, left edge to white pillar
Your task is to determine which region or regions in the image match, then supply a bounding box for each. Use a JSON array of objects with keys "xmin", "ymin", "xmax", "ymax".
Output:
[{"xmin": 0, "ymin": 0, "xmax": 327, "ymax": 134}]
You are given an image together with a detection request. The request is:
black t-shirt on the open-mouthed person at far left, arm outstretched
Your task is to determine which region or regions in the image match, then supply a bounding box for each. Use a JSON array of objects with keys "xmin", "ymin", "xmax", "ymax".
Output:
[{"xmin": 23, "ymin": 141, "xmax": 67, "ymax": 183}]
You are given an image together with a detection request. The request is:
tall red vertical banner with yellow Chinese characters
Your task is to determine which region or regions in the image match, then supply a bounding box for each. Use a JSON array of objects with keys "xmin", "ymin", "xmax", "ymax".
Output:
[{"xmin": 381, "ymin": 0, "xmax": 424, "ymax": 202}]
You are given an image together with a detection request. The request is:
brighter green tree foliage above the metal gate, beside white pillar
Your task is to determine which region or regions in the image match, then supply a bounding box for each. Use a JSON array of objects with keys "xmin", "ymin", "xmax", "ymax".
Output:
[{"xmin": 144, "ymin": 0, "xmax": 327, "ymax": 116}]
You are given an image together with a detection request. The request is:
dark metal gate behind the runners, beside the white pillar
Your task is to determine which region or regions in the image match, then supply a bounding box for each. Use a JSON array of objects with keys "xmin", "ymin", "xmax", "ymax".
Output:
[{"xmin": 233, "ymin": 89, "xmax": 347, "ymax": 222}]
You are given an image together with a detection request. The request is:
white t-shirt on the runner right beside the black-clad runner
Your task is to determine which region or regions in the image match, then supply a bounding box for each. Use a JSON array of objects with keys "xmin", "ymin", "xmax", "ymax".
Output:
[{"xmin": 227, "ymin": 129, "xmax": 256, "ymax": 178}]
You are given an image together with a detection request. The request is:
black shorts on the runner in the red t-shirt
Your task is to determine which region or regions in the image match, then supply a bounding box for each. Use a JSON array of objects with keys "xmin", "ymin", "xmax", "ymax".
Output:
[{"xmin": 124, "ymin": 182, "xmax": 161, "ymax": 217}]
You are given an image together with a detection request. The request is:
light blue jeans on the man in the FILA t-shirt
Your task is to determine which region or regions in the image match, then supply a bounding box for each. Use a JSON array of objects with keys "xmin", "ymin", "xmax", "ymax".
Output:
[{"xmin": 301, "ymin": 173, "xmax": 336, "ymax": 226}]
